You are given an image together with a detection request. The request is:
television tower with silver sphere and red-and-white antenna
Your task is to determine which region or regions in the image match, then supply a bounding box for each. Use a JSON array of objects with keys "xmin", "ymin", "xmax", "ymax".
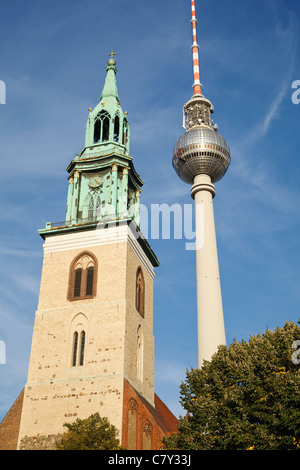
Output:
[{"xmin": 172, "ymin": 0, "xmax": 231, "ymax": 368}]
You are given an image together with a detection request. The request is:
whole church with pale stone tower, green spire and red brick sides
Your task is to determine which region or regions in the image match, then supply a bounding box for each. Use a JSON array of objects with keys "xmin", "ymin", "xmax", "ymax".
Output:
[{"xmin": 0, "ymin": 53, "xmax": 177, "ymax": 450}]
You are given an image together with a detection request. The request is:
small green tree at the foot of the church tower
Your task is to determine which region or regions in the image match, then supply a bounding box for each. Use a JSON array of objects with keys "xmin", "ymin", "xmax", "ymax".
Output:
[{"xmin": 56, "ymin": 413, "xmax": 122, "ymax": 450}]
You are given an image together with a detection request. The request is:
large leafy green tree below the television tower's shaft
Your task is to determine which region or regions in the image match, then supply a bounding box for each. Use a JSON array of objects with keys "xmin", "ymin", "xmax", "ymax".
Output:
[{"xmin": 164, "ymin": 322, "xmax": 300, "ymax": 450}]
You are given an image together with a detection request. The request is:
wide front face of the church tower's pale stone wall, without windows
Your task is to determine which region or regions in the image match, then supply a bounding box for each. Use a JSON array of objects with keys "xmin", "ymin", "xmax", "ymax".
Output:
[{"xmin": 20, "ymin": 237, "xmax": 126, "ymax": 446}]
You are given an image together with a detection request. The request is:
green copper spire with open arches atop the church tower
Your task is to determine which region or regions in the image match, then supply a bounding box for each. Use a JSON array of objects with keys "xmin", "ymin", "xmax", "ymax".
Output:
[{"xmin": 40, "ymin": 52, "xmax": 149, "ymax": 244}]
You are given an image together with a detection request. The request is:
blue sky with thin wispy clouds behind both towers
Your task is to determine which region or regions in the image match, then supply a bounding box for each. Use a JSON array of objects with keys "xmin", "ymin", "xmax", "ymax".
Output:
[{"xmin": 0, "ymin": 0, "xmax": 300, "ymax": 419}]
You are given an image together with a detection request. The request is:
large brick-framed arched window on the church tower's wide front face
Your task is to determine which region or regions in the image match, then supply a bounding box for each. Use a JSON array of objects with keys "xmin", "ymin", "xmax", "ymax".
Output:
[{"xmin": 68, "ymin": 252, "xmax": 97, "ymax": 300}]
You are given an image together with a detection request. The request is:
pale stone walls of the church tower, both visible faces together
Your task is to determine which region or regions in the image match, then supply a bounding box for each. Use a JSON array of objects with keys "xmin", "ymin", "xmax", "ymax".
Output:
[{"xmin": 19, "ymin": 227, "xmax": 154, "ymax": 448}]
